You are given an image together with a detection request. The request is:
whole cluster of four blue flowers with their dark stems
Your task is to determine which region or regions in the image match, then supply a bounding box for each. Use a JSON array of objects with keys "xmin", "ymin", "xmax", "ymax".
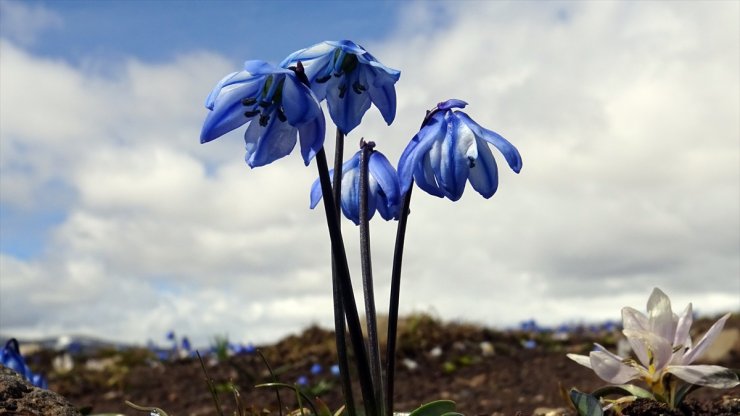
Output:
[{"xmin": 200, "ymin": 40, "xmax": 522, "ymax": 416}]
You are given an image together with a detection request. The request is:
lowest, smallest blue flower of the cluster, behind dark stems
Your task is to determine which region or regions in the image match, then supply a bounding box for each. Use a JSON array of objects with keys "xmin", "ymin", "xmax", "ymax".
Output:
[{"xmin": 311, "ymin": 146, "xmax": 401, "ymax": 225}]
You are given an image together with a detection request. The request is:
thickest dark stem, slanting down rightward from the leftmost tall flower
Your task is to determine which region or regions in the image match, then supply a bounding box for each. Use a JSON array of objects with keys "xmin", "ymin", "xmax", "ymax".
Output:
[{"xmin": 316, "ymin": 147, "xmax": 377, "ymax": 415}]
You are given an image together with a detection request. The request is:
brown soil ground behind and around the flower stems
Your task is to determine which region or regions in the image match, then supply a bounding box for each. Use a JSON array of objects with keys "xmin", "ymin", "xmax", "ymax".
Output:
[{"xmin": 24, "ymin": 315, "xmax": 740, "ymax": 416}]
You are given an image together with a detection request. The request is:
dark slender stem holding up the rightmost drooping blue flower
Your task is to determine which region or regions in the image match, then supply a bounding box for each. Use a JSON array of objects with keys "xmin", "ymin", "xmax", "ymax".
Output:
[{"xmin": 385, "ymin": 181, "xmax": 414, "ymax": 414}]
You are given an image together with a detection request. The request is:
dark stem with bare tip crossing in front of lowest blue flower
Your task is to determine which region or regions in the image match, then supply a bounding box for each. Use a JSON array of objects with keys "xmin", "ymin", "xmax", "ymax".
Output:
[{"xmin": 360, "ymin": 140, "xmax": 386, "ymax": 416}]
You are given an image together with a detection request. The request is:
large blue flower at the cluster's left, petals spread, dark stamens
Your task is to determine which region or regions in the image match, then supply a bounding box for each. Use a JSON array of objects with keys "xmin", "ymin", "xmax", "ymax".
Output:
[{"xmin": 200, "ymin": 61, "xmax": 326, "ymax": 168}]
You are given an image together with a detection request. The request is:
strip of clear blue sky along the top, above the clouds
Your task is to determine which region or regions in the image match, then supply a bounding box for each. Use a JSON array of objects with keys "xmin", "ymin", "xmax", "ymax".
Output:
[{"xmin": 11, "ymin": 0, "xmax": 402, "ymax": 64}]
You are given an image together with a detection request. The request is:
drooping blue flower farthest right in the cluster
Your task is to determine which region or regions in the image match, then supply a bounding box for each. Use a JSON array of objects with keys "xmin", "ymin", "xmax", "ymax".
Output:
[{"xmin": 398, "ymin": 99, "xmax": 522, "ymax": 201}]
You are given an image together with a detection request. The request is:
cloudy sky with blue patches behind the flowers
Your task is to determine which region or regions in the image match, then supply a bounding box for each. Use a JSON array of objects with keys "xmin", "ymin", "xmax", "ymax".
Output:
[{"xmin": 0, "ymin": 0, "xmax": 740, "ymax": 345}]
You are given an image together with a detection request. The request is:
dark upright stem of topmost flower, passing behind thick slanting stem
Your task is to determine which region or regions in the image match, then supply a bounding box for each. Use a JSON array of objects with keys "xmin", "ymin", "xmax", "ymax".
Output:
[{"xmin": 331, "ymin": 129, "xmax": 357, "ymax": 416}]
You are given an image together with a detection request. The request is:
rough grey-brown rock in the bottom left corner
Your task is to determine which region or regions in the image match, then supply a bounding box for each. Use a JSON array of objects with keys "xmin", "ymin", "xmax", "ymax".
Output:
[{"xmin": 0, "ymin": 365, "xmax": 82, "ymax": 416}]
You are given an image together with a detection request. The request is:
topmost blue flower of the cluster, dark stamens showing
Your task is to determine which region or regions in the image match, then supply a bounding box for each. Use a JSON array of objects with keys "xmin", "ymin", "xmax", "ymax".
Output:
[{"xmin": 280, "ymin": 40, "xmax": 401, "ymax": 134}]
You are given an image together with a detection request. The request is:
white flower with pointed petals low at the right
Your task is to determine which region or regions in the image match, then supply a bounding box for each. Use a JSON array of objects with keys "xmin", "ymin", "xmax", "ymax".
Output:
[{"xmin": 568, "ymin": 288, "xmax": 740, "ymax": 396}]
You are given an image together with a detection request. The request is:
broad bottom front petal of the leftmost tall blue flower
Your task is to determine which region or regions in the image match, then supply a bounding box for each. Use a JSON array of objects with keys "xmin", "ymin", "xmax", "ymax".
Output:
[{"xmin": 244, "ymin": 114, "xmax": 297, "ymax": 168}]
